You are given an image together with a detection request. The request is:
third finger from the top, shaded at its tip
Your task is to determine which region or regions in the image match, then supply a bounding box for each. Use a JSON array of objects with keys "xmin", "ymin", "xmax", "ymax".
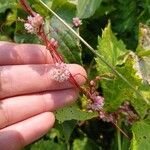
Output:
[{"xmin": 0, "ymin": 89, "xmax": 78, "ymax": 129}]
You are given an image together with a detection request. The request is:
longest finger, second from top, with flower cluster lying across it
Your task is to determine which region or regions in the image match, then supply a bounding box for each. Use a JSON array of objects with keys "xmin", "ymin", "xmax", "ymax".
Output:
[{"xmin": 0, "ymin": 64, "xmax": 86, "ymax": 99}]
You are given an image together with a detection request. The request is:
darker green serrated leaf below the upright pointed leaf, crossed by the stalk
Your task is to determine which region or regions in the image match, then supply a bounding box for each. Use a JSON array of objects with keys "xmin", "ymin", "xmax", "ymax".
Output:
[{"xmin": 101, "ymin": 54, "xmax": 141, "ymax": 111}]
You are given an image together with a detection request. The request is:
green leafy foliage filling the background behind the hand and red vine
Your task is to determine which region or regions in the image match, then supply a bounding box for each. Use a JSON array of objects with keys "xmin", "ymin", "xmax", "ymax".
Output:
[{"xmin": 0, "ymin": 0, "xmax": 150, "ymax": 150}]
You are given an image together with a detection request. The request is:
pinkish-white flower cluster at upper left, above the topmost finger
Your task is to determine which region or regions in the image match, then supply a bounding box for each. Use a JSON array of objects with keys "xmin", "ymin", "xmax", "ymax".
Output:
[{"xmin": 24, "ymin": 14, "xmax": 44, "ymax": 34}]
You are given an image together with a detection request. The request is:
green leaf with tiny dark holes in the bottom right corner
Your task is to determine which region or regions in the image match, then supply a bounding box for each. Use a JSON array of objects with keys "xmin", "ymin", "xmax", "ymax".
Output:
[{"xmin": 131, "ymin": 120, "xmax": 150, "ymax": 150}]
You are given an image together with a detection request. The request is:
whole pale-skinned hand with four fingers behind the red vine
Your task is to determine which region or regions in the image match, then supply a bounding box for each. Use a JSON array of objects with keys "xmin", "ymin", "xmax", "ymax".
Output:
[{"xmin": 0, "ymin": 42, "xmax": 86, "ymax": 150}]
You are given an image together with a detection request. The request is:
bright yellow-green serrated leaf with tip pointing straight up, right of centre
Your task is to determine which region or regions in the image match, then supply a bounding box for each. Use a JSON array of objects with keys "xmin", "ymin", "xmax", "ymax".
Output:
[{"xmin": 96, "ymin": 23, "xmax": 128, "ymax": 75}]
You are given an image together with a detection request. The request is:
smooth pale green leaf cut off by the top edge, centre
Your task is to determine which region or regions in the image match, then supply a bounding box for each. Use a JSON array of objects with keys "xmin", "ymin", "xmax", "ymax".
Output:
[{"xmin": 77, "ymin": 0, "xmax": 102, "ymax": 19}]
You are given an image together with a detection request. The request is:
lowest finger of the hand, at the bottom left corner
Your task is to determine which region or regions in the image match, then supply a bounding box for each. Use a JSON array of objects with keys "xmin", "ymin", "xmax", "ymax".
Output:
[{"xmin": 0, "ymin": 112, "xmax": 55, "ymax": 150}]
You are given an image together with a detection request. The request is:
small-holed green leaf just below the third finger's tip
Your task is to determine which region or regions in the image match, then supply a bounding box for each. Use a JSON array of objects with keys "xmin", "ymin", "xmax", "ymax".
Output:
[{"xmin": 56, "ymin": 104, "xmax": 98, "ymax": 123}]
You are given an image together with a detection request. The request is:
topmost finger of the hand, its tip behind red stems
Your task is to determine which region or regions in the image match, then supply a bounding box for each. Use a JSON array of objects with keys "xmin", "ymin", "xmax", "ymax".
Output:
[{"xmin": 0, "ymin": 42, "xmax": 52, "ymax": 65}]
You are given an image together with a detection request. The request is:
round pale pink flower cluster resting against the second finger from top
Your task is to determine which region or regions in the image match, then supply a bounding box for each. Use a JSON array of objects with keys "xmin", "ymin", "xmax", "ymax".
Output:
[{"xmin": 50, "ymin": 62, "xmax": 71, "ymax": 82}]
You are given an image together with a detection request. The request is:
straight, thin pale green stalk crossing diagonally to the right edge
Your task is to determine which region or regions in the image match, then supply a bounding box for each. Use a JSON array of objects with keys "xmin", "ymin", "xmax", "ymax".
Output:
[{"xmin": 39, "ymin": 0, "xmax": 150, "ymax": 105}]
